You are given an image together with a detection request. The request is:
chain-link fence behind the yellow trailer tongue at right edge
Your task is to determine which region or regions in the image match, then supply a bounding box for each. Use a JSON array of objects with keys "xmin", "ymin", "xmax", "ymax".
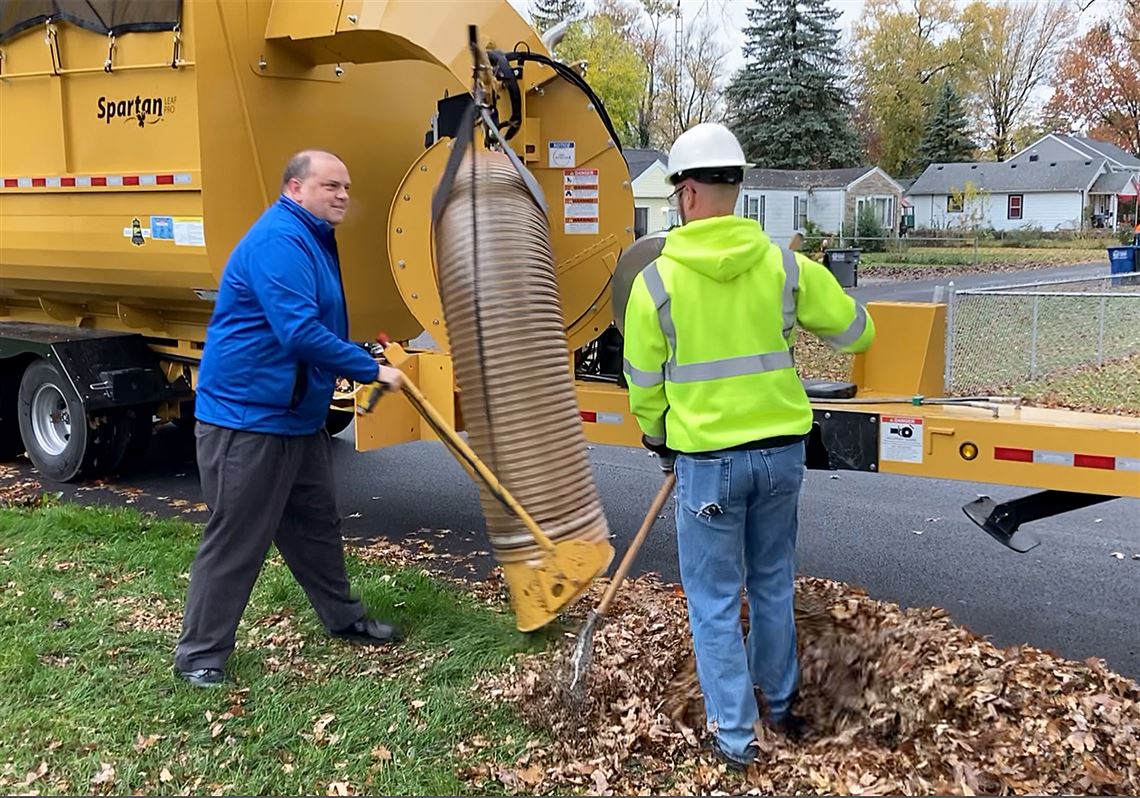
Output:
[{"xmin": 945, "ymin": 272, "xmax": 1140, "ymax": 396}]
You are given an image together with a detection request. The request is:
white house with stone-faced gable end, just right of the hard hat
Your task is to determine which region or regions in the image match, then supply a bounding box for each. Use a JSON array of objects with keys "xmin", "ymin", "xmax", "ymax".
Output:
[{"xmin": 736, "ymin": 166, "xmax": 903, "ymax": 244}]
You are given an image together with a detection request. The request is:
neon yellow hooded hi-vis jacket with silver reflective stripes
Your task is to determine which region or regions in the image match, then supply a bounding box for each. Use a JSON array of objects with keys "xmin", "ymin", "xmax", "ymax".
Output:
[{"xmin": 624, "ymin": 217, "xmax": 874, "ymax": 451}]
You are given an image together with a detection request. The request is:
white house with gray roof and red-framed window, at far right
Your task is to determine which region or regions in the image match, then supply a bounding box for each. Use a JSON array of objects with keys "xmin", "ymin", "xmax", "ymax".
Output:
[{"xmin": 907, "ymin": 157, "xmax": 1134, "ymax": 231}]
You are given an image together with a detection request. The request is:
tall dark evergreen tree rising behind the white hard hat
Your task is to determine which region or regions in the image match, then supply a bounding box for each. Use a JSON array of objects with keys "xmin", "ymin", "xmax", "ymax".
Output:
[{"xmin": 727, "ymin": 0, "xmax": 863, "ymax": 169}]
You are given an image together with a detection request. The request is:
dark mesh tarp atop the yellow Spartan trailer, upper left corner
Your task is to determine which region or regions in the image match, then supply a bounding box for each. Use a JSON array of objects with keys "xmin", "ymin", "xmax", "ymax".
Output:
[{"xmin": 0, "ymin": 0, "xmax": 182, "ymax": 42}]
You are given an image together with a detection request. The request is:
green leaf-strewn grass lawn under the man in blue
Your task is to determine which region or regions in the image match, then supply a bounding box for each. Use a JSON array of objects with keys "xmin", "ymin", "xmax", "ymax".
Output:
[{"xmin": 0, "ymin": 505, "xmax": 553, "ymax": 795}]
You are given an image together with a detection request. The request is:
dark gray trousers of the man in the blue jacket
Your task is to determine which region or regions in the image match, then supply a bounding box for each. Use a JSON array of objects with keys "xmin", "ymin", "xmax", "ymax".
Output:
[{"xmin": 174, "ymin": 422, "xmax": 364, "ymax": 670}]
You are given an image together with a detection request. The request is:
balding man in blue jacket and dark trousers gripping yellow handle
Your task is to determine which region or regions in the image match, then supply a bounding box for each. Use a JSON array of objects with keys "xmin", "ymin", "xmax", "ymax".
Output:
[{"xmin": 174, "ymin": 150, "xmax": 401, "ymax": 686}]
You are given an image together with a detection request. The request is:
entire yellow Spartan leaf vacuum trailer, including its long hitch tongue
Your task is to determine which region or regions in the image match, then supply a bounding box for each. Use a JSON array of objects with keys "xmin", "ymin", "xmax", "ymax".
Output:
[{"xmin": 0, "ymin": 0, "xmax": 1140, "ymax": 548}]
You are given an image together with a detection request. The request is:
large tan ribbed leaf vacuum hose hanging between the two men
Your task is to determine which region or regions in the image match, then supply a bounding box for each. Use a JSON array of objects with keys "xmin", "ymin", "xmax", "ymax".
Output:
[{"xmin": 434, "ymin": 149, "xmax": 613, "ymax": 628}]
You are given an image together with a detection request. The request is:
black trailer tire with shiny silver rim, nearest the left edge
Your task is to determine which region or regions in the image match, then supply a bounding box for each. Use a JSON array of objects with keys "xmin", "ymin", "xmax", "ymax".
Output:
[{"xmin": 18, "ymin": 359, "xmax": 115, "ymax": 482}]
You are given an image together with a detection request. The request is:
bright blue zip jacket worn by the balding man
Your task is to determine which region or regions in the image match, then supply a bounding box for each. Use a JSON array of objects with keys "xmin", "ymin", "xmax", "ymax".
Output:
[{"xmin": 195, "ymin": 196, "xmax": 376, "ymax": 435}]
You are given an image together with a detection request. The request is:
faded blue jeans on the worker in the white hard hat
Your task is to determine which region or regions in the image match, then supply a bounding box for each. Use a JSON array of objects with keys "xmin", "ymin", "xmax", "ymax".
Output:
[{"xmin": 674, "ymin": 443, "xmax": 804, "ymax": 760}]
